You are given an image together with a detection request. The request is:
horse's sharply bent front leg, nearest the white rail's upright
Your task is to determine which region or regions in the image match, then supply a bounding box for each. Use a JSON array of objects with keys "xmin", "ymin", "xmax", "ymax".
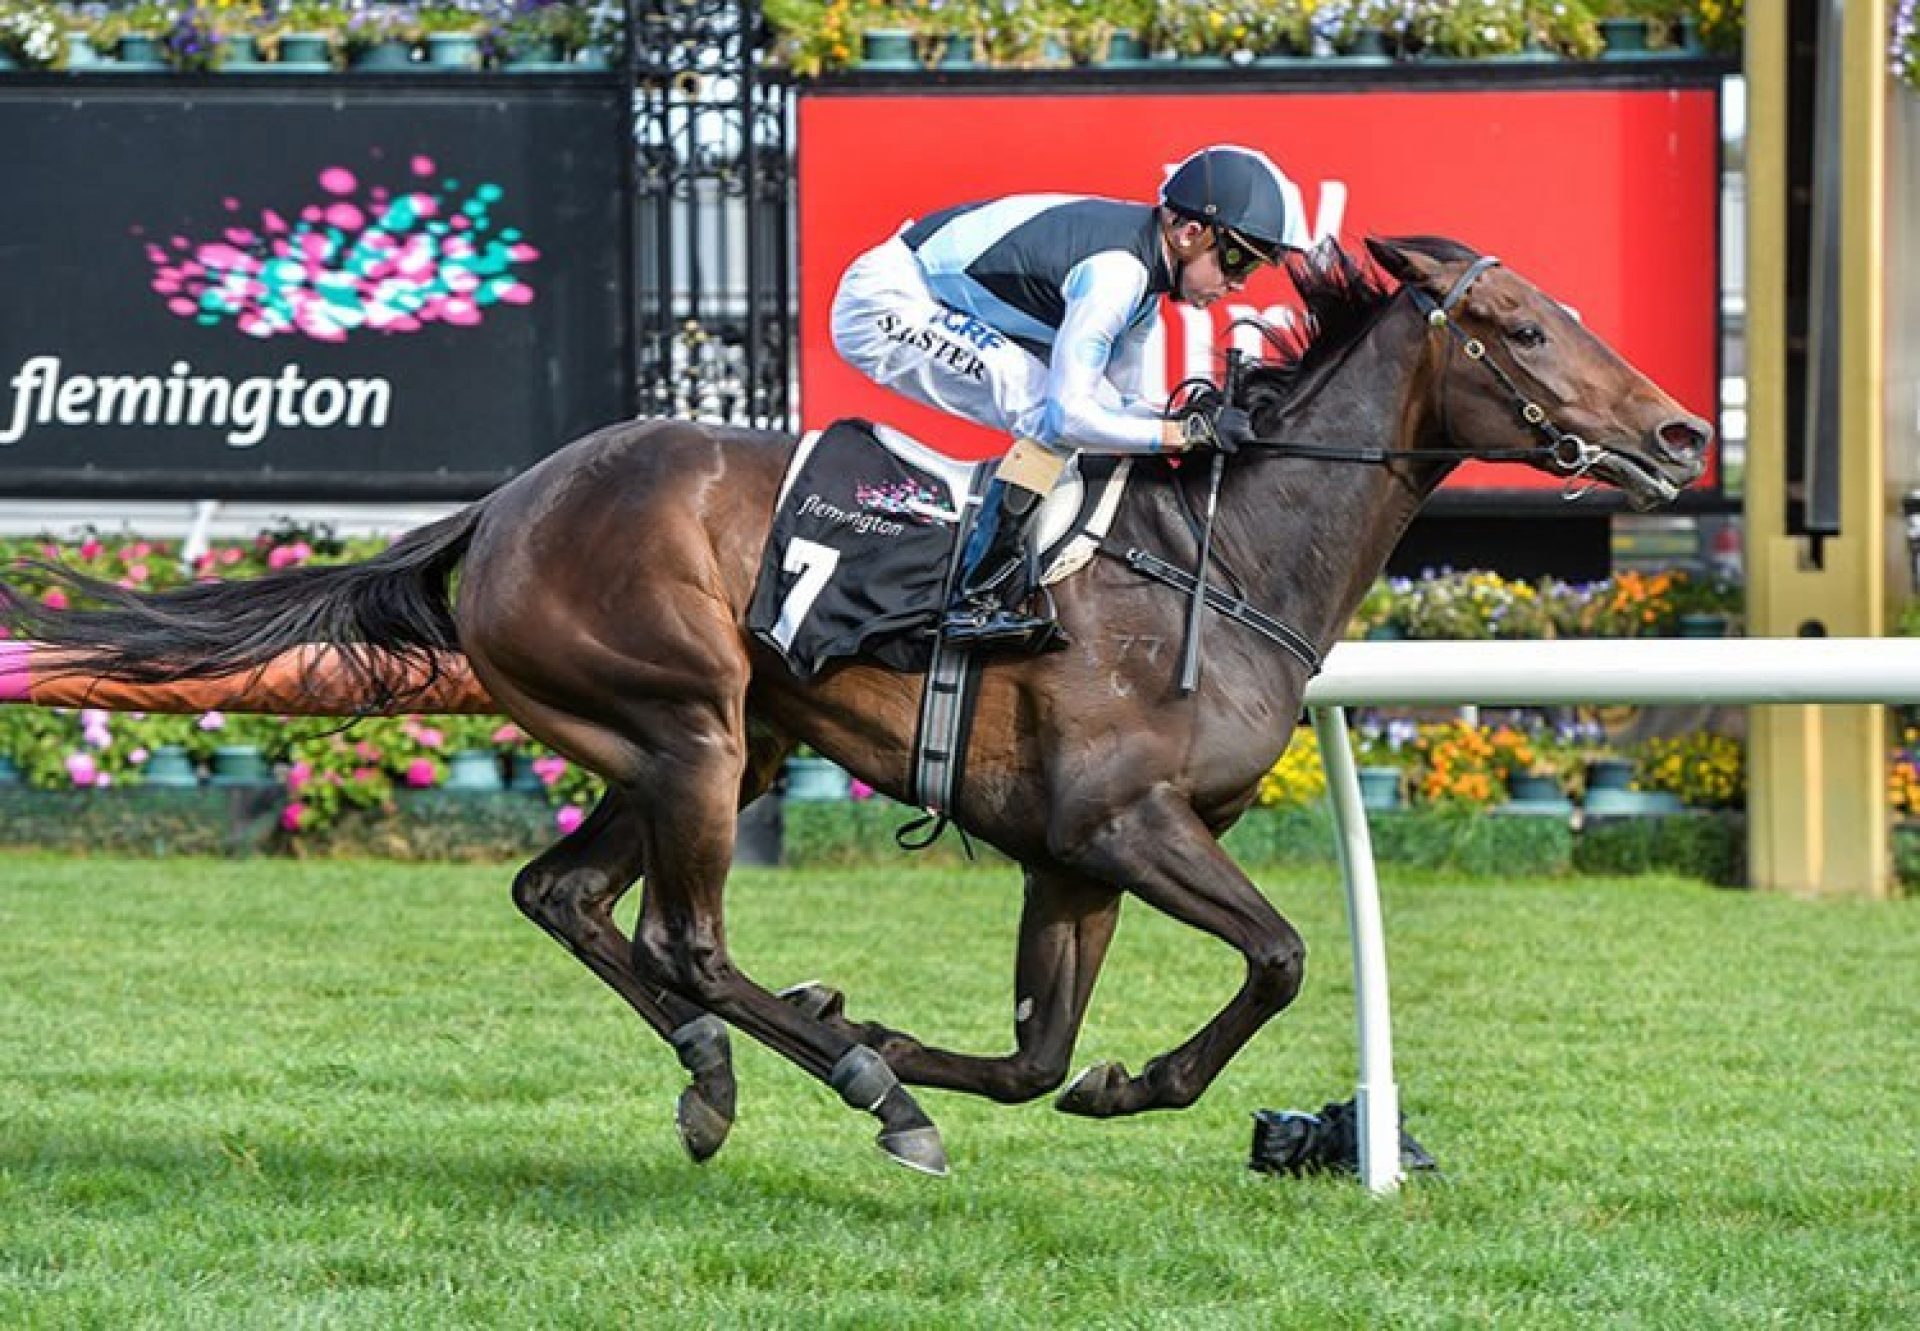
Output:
[{"xmin": 1058, "ymin": 787, "xmax": 1306, "ymax": 1118}]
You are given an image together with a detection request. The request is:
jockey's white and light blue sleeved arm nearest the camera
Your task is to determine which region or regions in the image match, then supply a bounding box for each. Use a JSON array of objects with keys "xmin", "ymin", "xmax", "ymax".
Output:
[{"xmin": 1033, "ymin": 250, "xmax": 1181, "ymax": 453}]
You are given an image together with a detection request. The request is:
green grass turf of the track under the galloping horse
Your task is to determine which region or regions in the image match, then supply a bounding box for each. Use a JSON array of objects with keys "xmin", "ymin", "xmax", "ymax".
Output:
[{"xmin": 0, "ymin": 859, "xmax": 1920, "ymax": 1331}]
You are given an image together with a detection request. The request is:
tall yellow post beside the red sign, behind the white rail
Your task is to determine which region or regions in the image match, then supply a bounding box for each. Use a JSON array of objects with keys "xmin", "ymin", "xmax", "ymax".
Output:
[{"xmin": 1745, "ymin": 0, "xmax": 1899, "ymax": 897}]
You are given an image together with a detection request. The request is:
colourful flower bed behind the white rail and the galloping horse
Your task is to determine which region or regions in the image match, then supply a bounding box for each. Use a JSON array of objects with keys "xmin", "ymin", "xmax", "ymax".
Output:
[{"xmin": 15, "ymin": 526, "xmax": 1920, "ymax": 875}]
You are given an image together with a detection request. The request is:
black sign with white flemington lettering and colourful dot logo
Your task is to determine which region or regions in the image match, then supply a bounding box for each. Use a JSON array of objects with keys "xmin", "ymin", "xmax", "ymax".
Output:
[{"xmin": 0, "ymin": 77, "xmax": 632, "ymax": 497}]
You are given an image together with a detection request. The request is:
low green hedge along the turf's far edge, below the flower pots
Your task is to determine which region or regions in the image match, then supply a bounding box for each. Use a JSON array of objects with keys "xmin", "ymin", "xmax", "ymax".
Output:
[{"xmin": 0, "ymin": 786, "xmax": 1766, "ymax": 885}]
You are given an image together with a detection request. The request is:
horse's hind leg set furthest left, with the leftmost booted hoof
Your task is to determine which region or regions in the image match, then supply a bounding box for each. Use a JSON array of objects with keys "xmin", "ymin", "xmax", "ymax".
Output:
[{"xmin": 513, "ymin": 791, "xmax": 733, "ymax": 1160}]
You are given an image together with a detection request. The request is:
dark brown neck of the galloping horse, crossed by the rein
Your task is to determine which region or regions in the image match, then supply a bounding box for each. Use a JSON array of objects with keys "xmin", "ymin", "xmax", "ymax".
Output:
[{"xmin": 1215, "ymin": 309, "xmax": 1450, "ymax": 643}]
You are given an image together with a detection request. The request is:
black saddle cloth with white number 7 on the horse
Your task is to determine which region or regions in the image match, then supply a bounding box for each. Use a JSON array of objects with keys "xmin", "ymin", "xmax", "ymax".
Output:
[{"xmin": 747, "ymin": 421, "xmax": 1129, "ymax": 680}]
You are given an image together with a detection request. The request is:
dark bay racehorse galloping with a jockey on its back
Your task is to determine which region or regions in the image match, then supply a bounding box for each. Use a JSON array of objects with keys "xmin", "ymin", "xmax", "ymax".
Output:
[{"xmin": 6, "ymin": 238, "xmax": 1711, "ymax": 1172}]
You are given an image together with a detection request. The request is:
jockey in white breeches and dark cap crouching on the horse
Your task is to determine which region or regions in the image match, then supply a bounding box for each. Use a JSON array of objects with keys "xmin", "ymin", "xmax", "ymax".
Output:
[{"xmin": 833, "ymin": 146, "xmax": 1308, "ymax": 649}]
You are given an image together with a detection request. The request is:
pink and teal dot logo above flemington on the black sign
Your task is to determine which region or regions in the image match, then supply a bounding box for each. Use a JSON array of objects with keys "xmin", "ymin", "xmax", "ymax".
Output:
[{"xmin": 146, "ymin": 157, "xmax": 540, "ymax": 342}]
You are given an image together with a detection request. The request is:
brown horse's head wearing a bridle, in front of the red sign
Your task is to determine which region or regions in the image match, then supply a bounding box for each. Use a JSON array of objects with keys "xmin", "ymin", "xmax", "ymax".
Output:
[{"xmin": 1367, "ymin": 238, "xmax": 1713, "ymax": 509}]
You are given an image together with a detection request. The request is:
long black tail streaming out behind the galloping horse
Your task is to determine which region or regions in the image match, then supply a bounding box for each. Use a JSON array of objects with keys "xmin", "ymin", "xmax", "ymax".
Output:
[{"xmin": 0, "ymin": 501, "xmax": 486, "ymax": 713}]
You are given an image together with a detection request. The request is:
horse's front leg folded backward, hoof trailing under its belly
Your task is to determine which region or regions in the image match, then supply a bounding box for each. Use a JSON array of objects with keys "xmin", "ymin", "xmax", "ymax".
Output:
[{"xmin": 781, "ymin": 866, "xmax": 1121, "ymax": 1104}]
